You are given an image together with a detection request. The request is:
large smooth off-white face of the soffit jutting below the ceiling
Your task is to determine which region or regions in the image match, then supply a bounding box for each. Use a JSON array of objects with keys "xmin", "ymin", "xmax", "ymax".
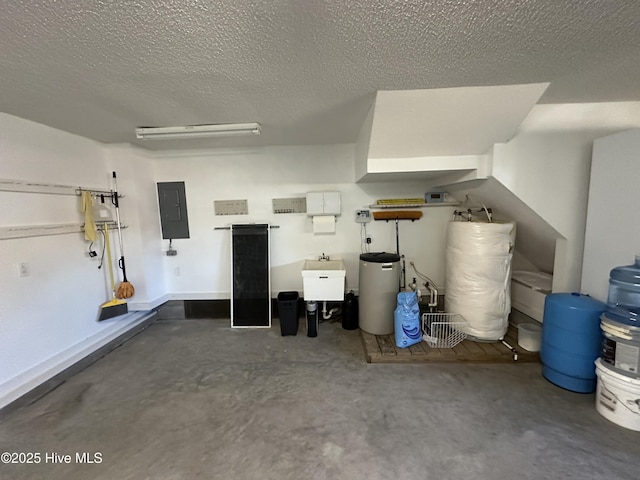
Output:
[{"xmin": 368, "ymin": 83, "xmax": 549, "ymax": 159}]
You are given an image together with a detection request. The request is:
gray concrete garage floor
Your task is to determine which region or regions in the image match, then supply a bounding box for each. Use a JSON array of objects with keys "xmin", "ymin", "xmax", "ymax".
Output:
[{"xmin": 0, "ymin": 319, "xmax": 640, "ymax": 480}]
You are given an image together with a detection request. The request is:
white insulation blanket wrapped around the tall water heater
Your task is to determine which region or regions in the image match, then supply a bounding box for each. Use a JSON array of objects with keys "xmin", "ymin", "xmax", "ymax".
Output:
[{"xmin": 445, "ymin": 222, "xmax": 516, "ymax": 340}]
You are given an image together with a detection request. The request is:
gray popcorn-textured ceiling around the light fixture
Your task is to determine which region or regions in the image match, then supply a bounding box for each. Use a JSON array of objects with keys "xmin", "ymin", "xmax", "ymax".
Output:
[{"xmin": 0, "ymin": 0, "xmax": 640, "ymax": 148}]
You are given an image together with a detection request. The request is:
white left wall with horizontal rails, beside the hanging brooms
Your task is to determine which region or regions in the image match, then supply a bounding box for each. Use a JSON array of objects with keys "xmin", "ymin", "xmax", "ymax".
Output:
[{"xmin": 0, "ymin": 114, "xmax": 151, "ymax": 407}]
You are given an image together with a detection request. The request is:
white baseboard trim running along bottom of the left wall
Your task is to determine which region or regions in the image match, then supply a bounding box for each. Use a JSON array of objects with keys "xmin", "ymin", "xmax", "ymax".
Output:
[{"xmin": 0, "ymin": 311, "xmax": 157, "ymax": 415}]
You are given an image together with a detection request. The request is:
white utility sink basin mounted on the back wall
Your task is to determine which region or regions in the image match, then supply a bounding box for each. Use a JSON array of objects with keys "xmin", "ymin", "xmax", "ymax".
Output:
[{"xmin": 302, "ymin": 260, "xmax": 347, "ymax": 302}]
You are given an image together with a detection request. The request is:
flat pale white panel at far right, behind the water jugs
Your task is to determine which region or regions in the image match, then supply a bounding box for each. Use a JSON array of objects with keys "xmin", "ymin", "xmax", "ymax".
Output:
[{"xmin": 582, "ymin": 130, "xmax": 640, "ymax": 302}]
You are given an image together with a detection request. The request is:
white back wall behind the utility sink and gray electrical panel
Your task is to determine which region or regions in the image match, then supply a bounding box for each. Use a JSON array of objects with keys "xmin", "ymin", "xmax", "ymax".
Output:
[{"xmin": 155, "ymin": 145, "xmax": 453, "ymax": 299}]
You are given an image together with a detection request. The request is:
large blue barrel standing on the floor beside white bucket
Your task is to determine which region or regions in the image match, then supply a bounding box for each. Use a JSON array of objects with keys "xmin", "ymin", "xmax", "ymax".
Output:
[{"xmin": 540, "ymin": 293, "xmax": 606, "ymax": 393}]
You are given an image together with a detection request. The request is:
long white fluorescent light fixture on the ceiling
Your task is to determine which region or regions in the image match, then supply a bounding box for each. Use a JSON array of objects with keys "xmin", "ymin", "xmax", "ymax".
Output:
[{"xmin": 136, "ymin": 123, "xmax": 260, "ymax": 140}]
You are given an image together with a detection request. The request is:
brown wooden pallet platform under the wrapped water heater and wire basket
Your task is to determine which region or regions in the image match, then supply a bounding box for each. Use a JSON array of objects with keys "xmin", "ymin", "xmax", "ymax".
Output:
[{"xmin": 360, "ymin": 325, "xmax": 540, "ymax": 363}]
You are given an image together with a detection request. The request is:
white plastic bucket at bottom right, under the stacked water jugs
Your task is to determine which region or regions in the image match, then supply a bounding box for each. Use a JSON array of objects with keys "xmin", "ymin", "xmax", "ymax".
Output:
[{"xmin": 596, "ymin": 358, "xmax": 640, "ymax": 432}]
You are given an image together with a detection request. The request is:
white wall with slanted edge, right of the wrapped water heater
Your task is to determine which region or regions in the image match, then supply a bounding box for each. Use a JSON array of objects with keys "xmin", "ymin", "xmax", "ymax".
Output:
[{"xmin": 493, "ymin": 102, "xmax": 640, "ymax": 292}]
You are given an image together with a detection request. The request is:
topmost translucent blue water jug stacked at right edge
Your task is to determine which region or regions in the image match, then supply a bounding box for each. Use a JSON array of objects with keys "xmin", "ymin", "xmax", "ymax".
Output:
[{"xmin": 607, "ymin": 254, "xmax": 640, "ymax": 326}]
